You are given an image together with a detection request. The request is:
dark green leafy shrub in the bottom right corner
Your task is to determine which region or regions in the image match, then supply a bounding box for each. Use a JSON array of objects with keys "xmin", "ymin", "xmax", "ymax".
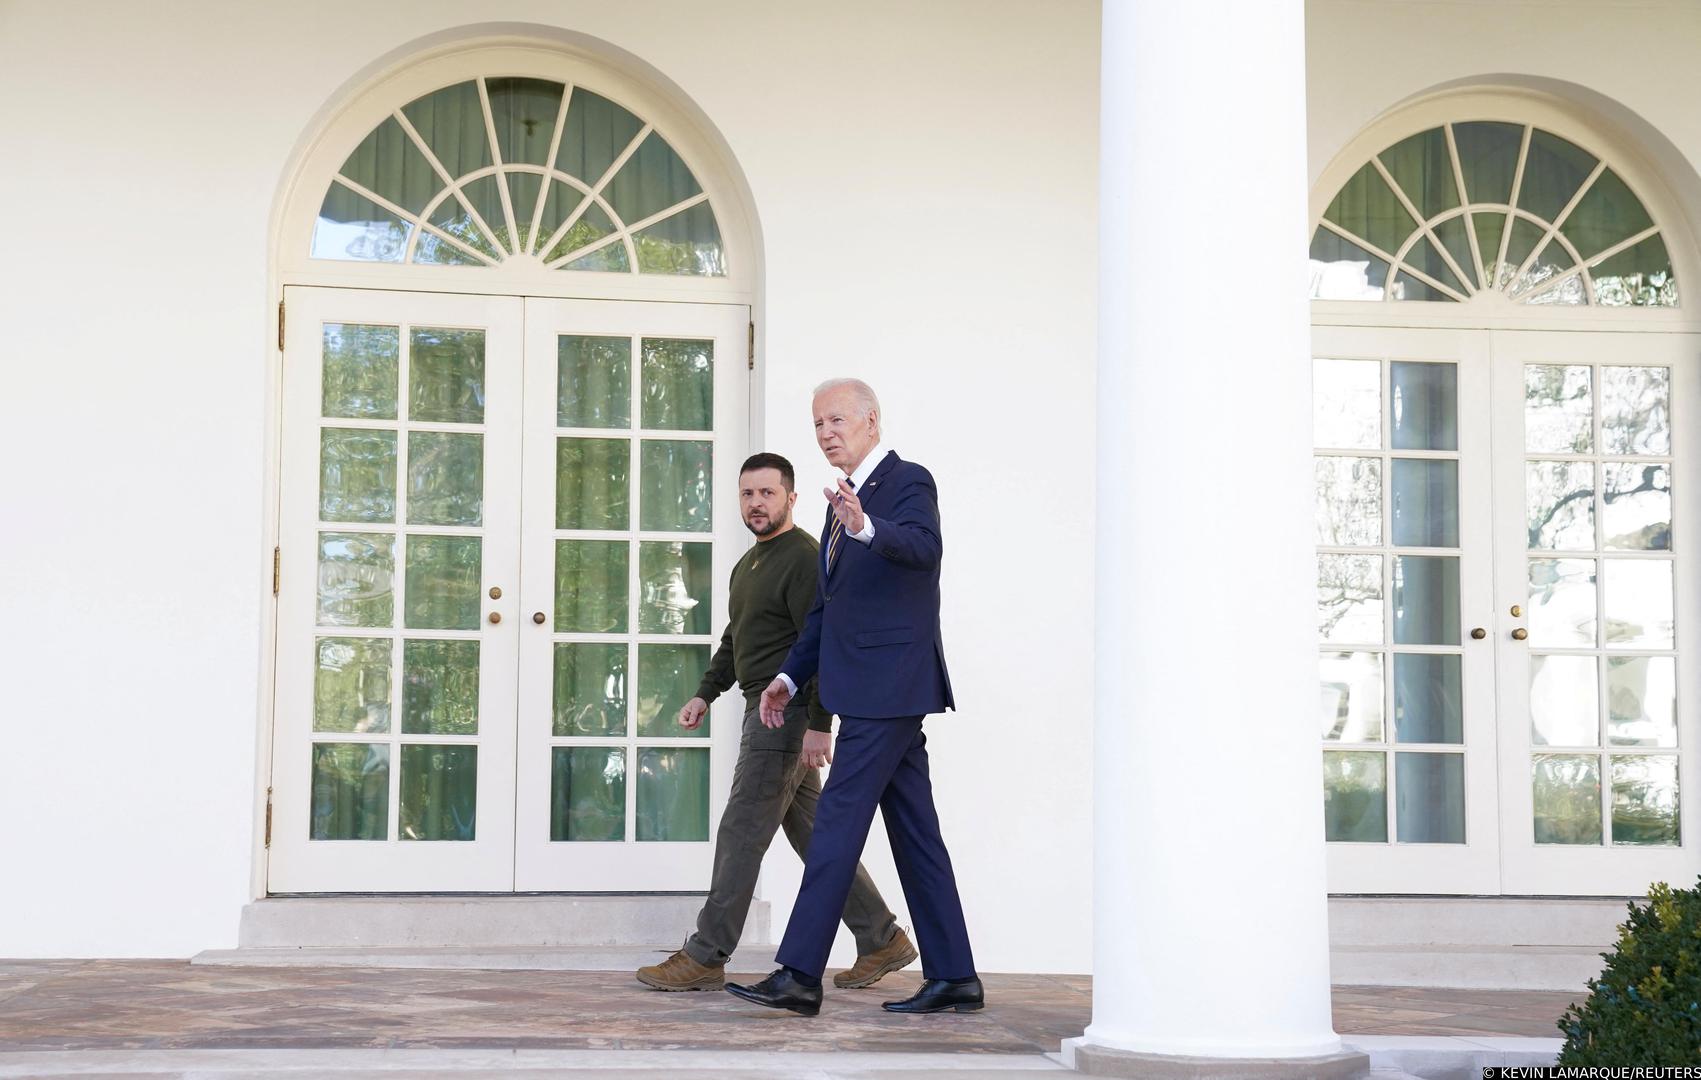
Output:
[{"xmin": 1560, "ymin": 883, "xmax": 1701, "ymax": 1065}]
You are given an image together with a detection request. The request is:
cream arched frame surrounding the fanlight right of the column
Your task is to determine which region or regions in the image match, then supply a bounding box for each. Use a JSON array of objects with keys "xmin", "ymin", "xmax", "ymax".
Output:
[{"xmin": 1306, "ymin": 88, "xmax": 1701, "ymax": 330}]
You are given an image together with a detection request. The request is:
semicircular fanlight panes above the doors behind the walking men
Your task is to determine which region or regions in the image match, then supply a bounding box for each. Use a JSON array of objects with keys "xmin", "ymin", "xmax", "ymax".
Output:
[{"xmin": 313, "ymin": 78, "xmax": 726, "ymax": 276}]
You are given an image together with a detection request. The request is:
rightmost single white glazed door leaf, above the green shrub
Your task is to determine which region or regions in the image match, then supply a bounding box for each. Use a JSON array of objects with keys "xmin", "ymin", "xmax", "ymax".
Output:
[{"xmin": 1493, "ymin": 332, "xmax": 1701, "ymax": 895}]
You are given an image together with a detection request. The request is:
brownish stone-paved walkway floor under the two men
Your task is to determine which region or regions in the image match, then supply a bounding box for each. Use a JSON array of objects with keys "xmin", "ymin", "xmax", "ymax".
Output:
[{"xmin": 0, "ymin": 959, "xmax": 1573, "ymax": 1054}]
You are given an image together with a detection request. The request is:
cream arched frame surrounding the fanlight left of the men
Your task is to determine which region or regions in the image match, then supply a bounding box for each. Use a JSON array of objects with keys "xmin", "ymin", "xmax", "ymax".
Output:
[{"xmin": 274, "ymin": 39, "xmax": 760, "ymax": 303}]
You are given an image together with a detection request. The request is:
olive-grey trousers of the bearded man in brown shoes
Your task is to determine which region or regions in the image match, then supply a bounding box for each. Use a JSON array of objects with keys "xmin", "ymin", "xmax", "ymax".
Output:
[{"xmin": 686, "ymin": 697, "xmax": 898, "ymax": 968}]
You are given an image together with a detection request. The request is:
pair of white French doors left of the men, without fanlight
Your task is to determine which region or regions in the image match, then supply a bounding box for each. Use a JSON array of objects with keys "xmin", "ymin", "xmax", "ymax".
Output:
[{"xmin": 267, "ymin": 287, "xmax": 748, "ymax": 893}]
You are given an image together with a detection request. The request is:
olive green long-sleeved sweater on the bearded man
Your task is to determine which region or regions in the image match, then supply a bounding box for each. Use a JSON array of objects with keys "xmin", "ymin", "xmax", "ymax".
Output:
[{"xmin": 697, "ymin": 529, "xmax": 833, "ymax": 731}]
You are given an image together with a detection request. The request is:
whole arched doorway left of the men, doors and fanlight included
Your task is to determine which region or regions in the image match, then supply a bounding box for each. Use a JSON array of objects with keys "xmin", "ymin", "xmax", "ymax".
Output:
[{"xmin": 267, "ymin": 44, "xmax": 757, "ymax": 893}]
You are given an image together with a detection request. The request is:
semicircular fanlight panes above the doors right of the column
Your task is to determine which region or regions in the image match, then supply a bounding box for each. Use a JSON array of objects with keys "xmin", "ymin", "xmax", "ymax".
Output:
[{"xmin": 1311, "ymin": 121, "xmax": 1677, "ymax": 308}]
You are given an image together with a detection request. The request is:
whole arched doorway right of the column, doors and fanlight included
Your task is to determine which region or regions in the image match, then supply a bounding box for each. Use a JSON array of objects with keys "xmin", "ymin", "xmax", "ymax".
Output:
[{"xmin": 1311, "ymin": 92, "xmax": 1701, "ymax": 895}]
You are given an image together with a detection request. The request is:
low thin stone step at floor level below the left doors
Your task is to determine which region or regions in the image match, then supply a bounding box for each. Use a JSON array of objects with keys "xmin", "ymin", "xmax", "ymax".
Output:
[{"xmin": 189, "ymin": 945, "xmax": 777, "ymax": 975}]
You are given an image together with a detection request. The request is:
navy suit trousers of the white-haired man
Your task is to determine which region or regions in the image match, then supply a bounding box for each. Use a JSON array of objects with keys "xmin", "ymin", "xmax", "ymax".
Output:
[{"xmin": 779, "ymin": 716, "xmax": 975, "ymax": 980}]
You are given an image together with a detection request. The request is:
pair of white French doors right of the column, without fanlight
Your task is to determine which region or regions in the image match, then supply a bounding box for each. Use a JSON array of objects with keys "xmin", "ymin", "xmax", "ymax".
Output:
[{"xmin": 1313, "ymin": 327, "xmax": 1701, "ymax": 895}]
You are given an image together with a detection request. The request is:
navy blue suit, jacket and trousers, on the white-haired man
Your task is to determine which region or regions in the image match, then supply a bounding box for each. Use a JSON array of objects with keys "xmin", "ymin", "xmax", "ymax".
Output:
[{"xmin": 779, "ymin": 452, "xmax": 975, "ymax": 980}]
